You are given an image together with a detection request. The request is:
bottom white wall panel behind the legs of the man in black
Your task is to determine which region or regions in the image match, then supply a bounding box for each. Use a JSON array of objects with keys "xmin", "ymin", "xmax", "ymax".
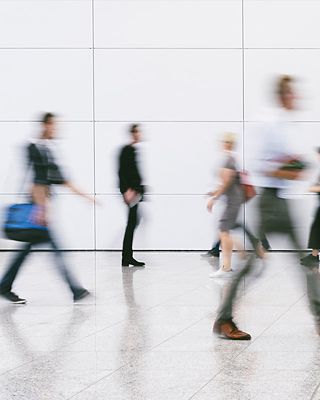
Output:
[{"xmin": 96, "ymin": 195, "xmax": 220, "ymax": 250}]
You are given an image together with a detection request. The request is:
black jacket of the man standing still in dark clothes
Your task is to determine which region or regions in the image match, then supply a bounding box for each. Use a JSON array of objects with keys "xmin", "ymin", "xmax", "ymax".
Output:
[{"xmin": 119, "ymin": 145, "xmax": 144, "ymax": 194}]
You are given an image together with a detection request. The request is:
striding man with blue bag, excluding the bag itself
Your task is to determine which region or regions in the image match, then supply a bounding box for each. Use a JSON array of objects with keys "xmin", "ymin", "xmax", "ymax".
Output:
[{"xmin": 0, "ymin": 113, "xmax": 92, "ymax": 304}]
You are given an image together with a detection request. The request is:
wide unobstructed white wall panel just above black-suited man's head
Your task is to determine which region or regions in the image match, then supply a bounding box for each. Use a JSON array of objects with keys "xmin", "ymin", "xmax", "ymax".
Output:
[{"xmin": 95, "ymin": 50, "xmax": 242, "ymax": 121}]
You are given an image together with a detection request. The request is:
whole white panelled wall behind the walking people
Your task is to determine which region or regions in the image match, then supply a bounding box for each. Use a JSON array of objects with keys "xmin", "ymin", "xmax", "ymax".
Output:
[{"xmin": 0, "ymin": 0, "xmax": 320, "ymax": 249}]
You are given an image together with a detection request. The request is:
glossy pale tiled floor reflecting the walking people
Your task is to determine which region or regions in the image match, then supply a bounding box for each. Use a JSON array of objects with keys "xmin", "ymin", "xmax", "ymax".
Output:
[{"xmin": 0, "ymin": 252, "xmax": 320, "ymax": 400}]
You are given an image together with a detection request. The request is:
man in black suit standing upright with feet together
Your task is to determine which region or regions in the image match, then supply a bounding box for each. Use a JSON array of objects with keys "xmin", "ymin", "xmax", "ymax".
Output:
[{"xmin": 119, "ymin": 124, "xmax": 145, "ymax": 267}]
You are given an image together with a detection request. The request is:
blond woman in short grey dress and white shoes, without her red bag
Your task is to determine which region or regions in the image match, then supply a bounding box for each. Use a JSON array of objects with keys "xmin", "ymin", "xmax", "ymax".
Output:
[{"xmin": 207, "ymin": 133, "xmax": 244, "ymax": 278}]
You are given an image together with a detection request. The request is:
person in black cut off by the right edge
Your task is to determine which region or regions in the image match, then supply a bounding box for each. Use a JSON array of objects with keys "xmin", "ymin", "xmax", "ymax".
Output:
[{"xmin": 301, "ymin": 147, "xmax": 320, "ymax": 267}]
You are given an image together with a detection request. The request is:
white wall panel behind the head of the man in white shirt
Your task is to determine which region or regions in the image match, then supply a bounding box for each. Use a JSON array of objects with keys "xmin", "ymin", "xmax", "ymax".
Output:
[{"xmin": 245, "ymin": 49, "xmax": 320, "ymax": 121}]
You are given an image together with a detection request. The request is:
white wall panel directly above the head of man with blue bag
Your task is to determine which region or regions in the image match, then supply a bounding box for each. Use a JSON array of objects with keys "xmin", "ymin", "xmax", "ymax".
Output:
[{"xmin": 0, "ymin": 50, "xmax": 92, "ymax": 121}]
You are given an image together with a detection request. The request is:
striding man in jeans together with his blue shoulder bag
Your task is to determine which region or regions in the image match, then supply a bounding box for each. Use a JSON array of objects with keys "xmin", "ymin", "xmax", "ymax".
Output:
[{"xmin": 0, "ymin": 113, "xmax": 93, "ymax": 304}]
